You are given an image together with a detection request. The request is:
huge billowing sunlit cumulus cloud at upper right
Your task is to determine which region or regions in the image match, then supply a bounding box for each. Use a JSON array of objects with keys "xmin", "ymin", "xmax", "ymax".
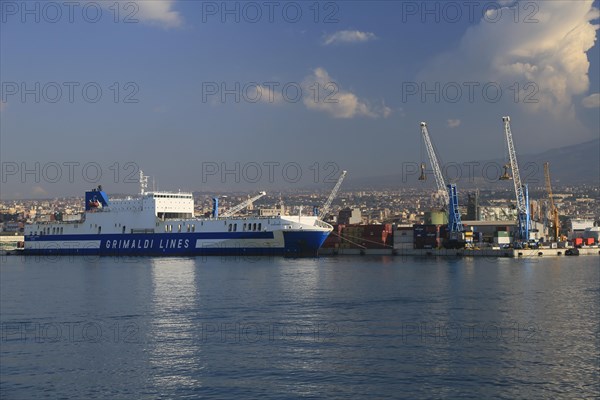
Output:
[{"xmin": 422, "ymin": 0, "xmax": 598, "ymax": 115}]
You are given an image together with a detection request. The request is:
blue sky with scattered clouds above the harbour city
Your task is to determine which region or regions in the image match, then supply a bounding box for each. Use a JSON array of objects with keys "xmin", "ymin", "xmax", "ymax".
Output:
[{"xmin": 0, "ymin": 0, "xmax": 600, "ymax": 198}]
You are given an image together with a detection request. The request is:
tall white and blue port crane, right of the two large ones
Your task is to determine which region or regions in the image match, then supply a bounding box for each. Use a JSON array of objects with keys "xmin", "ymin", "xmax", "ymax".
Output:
[{"xmin": 500, "ymin": 116, "xmax": 530, "ymax": 242}]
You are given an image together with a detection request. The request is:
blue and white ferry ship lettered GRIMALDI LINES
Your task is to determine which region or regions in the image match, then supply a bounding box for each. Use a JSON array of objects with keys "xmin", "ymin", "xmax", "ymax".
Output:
[{"xmin": 24, "ymin": 175, "xmax": 333, "ymax": 257}]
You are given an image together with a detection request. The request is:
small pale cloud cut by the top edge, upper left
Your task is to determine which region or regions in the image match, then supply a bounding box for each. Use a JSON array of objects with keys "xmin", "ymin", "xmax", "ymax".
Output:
[{"xmin": 109, "ymin": 0, "xmax": 183, "ymax": 28}]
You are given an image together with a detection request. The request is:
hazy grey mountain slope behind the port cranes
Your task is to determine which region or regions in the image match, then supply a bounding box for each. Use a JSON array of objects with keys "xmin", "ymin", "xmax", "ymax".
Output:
[{"xmin": 344, "ymin": 139, "xmax": 600, "ymax": 189}]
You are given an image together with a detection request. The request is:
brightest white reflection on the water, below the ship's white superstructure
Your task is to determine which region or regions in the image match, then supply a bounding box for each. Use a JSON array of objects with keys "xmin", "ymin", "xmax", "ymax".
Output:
[{"xmin": 149, "ymin": 258, "xmax": 204, "ymax": 393}]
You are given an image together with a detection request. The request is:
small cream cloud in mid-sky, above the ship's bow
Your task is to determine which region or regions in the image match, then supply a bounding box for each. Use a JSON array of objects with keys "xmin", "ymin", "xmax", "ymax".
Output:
[{"xmin": 302, "ymin": 68, "xmax": 392, "ymax": 118}]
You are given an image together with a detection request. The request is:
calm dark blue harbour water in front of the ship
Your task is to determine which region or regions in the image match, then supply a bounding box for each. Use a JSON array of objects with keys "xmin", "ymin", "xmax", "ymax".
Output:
[{"xmin": 0, "ymin": 256, "xmax": 600, "ymax": 400}]
